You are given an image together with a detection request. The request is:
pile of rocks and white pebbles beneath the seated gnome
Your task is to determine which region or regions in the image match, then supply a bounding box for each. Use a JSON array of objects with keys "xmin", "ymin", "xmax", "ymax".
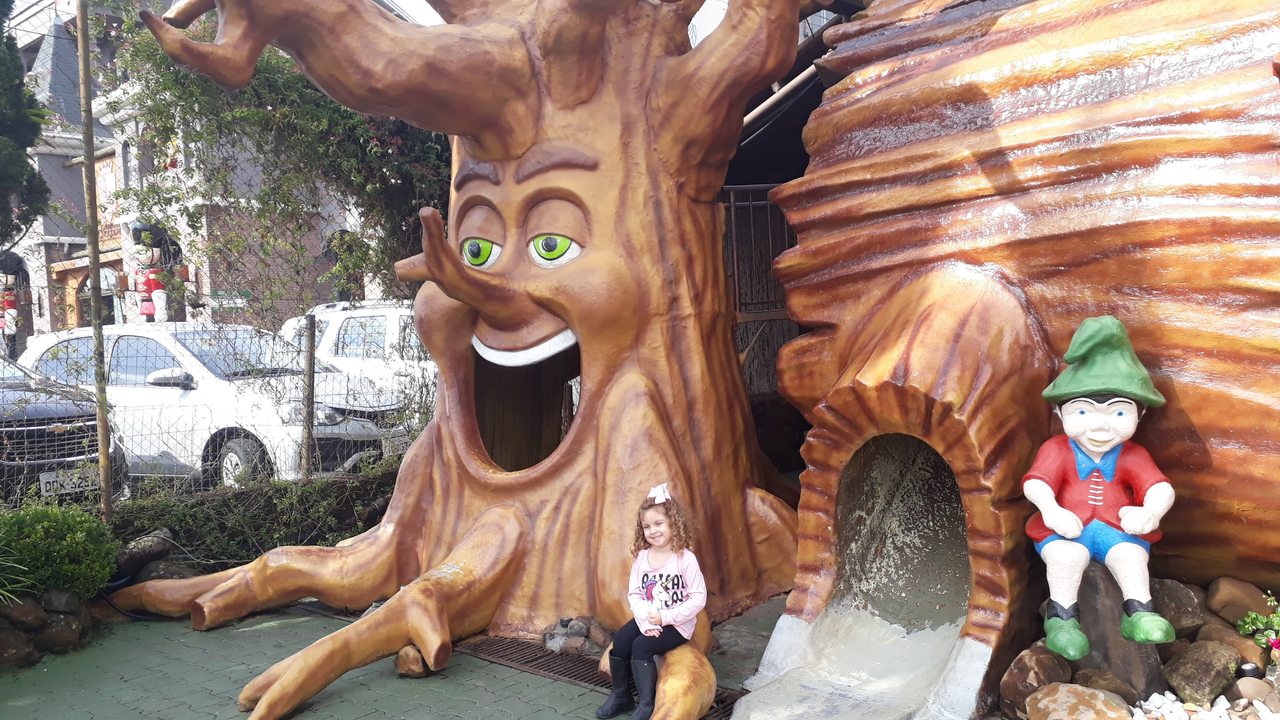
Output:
[{"xmin": 1000, "ymin": 564, "xmax": 1280, "ymax": 720}]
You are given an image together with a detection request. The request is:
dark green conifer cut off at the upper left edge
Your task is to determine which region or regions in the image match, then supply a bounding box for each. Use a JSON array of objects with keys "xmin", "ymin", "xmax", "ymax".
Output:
[{"xmin": 0, "ymin": 0, "xmax": 49, "ymax": 251}]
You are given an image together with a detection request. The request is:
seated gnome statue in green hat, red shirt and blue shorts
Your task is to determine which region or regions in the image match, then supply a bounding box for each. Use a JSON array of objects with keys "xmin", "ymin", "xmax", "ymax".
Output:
[{"xmin": 1023, "ymin": 315, "xmax": 1174, "ymax": 660}]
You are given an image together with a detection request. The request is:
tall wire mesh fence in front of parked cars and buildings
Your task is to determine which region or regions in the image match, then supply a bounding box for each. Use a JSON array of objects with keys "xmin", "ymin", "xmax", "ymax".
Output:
[{"xmin": 0, "ymin": 0, "xmax": 448, "ymax": 505}]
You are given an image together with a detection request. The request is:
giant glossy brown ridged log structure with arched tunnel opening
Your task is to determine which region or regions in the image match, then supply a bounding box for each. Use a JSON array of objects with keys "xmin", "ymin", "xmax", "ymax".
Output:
[{"xmin": 757, "ymin": 0, "xmax": 1280, "ymax": 716}]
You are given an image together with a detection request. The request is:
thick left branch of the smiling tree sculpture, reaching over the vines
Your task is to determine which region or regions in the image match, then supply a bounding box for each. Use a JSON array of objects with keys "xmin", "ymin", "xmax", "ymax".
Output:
[{"xmin": 142, "ymin": 0, "xmax": 538, "ymax": 158}]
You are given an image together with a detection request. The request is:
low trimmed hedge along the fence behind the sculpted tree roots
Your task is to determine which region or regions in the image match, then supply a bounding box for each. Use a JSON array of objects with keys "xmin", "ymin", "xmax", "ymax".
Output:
[{"xmin": 111, "ymin": 466, "xmax": 396, "ymax": 571}]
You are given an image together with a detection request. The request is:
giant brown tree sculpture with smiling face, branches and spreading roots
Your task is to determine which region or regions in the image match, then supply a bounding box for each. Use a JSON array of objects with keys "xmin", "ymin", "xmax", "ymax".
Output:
[{"xmin": 115, "ymin": 0, "xmax": 797, "ymax": 719}]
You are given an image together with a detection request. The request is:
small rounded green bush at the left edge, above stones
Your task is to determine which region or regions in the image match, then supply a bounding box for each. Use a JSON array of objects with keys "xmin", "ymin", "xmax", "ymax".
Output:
[{"xmin": 0, "ymin": 505, "xmax": 119, "ymax": 600}]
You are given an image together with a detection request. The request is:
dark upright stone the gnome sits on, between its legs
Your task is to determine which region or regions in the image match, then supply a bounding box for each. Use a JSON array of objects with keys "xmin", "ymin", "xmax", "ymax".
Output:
[{"xmin": 1076, "ymin": 562, "xmax": 1172, "ymax": 700}]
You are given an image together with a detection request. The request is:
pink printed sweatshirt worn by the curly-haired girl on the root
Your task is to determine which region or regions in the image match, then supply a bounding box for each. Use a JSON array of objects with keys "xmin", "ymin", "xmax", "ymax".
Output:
[{"xmin": 627, "ymin": 550, "xmax": 707, "ymax": 639}]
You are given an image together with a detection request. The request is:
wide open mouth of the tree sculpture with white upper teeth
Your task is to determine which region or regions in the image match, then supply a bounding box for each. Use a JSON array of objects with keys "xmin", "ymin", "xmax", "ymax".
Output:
[{"xmin": 471, "ymin": 329, "xmax": 581, "ymax": 471}]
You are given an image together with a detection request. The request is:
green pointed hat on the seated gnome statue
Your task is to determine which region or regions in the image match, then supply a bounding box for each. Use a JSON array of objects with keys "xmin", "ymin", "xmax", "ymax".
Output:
[{"xmin": 1043, "ymin": 315, "xmax": 1165, "ymax": 407}]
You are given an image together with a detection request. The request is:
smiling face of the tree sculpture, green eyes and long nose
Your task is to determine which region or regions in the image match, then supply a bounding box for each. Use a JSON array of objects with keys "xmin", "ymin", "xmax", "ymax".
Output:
[{"xmin": 443, "ymin": 143, "xmax": 636, "ymax": 366}]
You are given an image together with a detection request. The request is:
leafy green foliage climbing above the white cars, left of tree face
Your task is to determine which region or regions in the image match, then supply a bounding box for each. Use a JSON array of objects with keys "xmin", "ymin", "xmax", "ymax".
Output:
[{"xmin": 108, "ymin": 12, "xmax": 449, "ymax": 299}]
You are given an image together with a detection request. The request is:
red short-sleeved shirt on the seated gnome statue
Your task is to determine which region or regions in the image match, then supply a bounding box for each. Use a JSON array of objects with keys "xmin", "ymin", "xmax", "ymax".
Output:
[{"xmin": 1023, "ymin": 436, "xmax": 1169, "ymax": 542}]
